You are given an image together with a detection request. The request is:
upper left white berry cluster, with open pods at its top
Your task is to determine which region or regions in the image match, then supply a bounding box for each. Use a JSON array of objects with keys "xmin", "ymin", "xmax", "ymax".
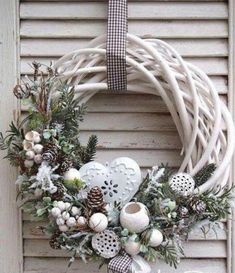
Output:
[{"xmin": 23, "ymin": 131, "xmax": 43, "ymax": 168}]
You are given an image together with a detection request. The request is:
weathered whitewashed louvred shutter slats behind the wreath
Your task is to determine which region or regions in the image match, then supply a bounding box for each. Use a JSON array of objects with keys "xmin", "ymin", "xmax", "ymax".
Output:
[{"xmin": 17, "ymin": 0, "xmax": 233, "ymax": 273}]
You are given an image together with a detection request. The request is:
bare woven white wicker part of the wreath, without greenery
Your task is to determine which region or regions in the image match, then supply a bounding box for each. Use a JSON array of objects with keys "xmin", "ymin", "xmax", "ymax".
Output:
[{"xmin": 54, "ymin": 34, "xmax": 235, "ymax": 192}]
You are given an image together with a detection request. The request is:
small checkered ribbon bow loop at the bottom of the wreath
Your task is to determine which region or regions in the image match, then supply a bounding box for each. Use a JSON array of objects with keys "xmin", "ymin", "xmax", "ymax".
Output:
[{"xmin": 108, "ymin": 253, "xmax": 132, "ymax": 273}]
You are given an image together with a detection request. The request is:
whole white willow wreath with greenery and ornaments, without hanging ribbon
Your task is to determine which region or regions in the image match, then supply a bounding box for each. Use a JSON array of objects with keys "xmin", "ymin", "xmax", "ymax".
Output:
[{"xmin": 0, "ymin": 34, "xmax": 234, "ymax": 273}]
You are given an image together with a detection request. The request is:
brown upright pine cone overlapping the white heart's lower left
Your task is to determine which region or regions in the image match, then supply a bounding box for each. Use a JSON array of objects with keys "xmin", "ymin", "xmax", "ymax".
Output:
[{"xmin": 87, "ymin": 186, "xmax": 105, "ymax": 213}]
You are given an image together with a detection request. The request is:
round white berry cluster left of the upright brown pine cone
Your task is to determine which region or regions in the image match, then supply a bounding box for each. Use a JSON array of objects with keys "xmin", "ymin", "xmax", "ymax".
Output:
[{"xmin": 51, "ymin": 201, "xmax": 81, "ymax": 232}]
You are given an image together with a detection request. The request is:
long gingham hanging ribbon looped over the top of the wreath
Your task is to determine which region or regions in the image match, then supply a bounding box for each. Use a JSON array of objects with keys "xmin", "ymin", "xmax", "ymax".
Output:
[{"xmin": 106, "ymin": 0, "xmax": 128, "ymax": 91}]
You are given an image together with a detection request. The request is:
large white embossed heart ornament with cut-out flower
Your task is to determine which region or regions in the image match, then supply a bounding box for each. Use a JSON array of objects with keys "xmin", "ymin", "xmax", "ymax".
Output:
[{"xmin": 79, "ymin": 157, "xmax": 141, "ymax": 204}]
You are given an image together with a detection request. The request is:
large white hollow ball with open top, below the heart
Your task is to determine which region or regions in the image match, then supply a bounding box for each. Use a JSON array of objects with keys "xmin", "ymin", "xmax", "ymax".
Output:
[{"xmin": 120, "ymin": 202, "xmax": 149, "ymax": 233}]
